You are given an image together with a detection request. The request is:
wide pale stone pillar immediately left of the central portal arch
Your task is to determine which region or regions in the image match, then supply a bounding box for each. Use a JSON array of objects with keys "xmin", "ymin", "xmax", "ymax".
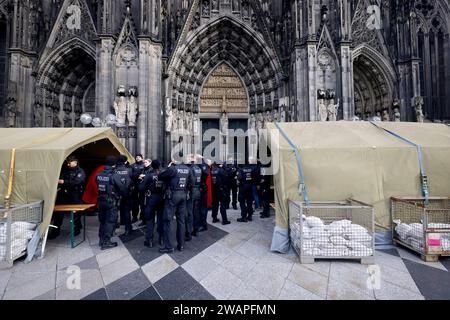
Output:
[{"xmin": 137, "ymin": 37, "xmax": 164, "ymax": 159}]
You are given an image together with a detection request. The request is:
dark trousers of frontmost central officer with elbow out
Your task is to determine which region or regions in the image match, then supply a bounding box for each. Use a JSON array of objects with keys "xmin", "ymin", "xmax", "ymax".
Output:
[{"xmin": 163, "ymin": 191, "xmax": 187, "ymax": 250}]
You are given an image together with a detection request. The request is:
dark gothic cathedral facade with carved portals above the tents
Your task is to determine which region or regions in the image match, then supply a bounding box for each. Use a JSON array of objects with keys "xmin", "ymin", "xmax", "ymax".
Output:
[{"xmin": 0, "ymin": 0, "xmax": 450, "ymax": 159}]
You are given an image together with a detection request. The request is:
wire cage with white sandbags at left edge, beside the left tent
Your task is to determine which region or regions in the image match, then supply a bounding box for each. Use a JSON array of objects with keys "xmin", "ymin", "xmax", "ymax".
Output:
[{"xmin": 0, "ymin": 201, "xmax": 43, "ymax": 268}]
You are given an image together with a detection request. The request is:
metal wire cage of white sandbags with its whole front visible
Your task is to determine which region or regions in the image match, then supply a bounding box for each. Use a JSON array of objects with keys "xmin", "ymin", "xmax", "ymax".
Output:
[{"xmin": 289, "ymin": 199, "xmax": 375, "ymax": 264}]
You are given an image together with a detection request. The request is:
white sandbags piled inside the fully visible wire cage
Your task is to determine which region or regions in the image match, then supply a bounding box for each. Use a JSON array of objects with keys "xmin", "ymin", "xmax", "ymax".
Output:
[{"xmin": 294, "ymin": 217, "xmax": 373, "ymax": 257}]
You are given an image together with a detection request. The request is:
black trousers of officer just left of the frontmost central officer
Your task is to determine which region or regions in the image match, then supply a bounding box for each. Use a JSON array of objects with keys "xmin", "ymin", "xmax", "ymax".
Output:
[{"xmin": 144, "ymin": 194, "xmax": 164, "ymax": 241}]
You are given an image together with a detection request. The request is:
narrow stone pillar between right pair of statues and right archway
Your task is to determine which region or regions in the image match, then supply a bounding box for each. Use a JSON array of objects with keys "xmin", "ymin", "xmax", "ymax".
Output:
[{"xmin": 338, "ymin": 44, "xmax": 355, "ymax": 121}]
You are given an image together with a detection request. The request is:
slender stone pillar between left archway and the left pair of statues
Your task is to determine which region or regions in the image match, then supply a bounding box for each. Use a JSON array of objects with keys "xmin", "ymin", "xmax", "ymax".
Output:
[{"xmin": 95, "ymin": 37, "xmax": 117, "ymax": 119}]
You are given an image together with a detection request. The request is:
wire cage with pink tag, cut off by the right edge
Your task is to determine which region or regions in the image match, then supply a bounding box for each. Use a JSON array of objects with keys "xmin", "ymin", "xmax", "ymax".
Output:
[{"xmin": 391, "ymin": 197, "xmax": 450, "ymax": 261}]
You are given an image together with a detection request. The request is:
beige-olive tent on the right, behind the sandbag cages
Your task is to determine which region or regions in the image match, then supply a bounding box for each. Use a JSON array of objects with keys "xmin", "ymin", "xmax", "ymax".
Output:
[{"xmin": 267, "ymin": 122, "xmax": 450, "ymax": 252}]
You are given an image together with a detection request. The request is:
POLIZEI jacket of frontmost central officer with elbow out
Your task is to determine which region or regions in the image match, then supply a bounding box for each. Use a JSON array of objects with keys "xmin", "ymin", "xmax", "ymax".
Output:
[{"xmin": 158, "ymin": 164, "xmax": 194, "ymax": 192}]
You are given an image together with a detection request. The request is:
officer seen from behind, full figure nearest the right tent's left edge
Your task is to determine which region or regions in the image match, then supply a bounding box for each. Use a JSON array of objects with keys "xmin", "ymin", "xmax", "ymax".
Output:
[{"xmin": 237, "ymin": 161, "xmax": 259, "ymax": 222}]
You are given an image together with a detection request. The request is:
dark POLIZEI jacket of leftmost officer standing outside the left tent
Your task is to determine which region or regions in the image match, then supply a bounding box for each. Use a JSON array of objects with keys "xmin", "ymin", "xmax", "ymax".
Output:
[{"xmin": 95, "ymin": 166, "xmax": 126, "ymax": 201}]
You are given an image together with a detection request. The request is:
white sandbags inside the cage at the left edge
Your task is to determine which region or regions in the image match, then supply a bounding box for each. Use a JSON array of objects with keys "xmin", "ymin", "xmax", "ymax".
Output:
[{"xmin": 0, "ymin": 221, "xmax": 37, "ymax": 260}]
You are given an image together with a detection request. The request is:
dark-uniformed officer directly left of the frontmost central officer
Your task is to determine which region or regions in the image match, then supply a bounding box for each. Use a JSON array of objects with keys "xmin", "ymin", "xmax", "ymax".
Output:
[{"xmin": 139, "ymin": 160, "xmax": 165, "ymax": 248}]
